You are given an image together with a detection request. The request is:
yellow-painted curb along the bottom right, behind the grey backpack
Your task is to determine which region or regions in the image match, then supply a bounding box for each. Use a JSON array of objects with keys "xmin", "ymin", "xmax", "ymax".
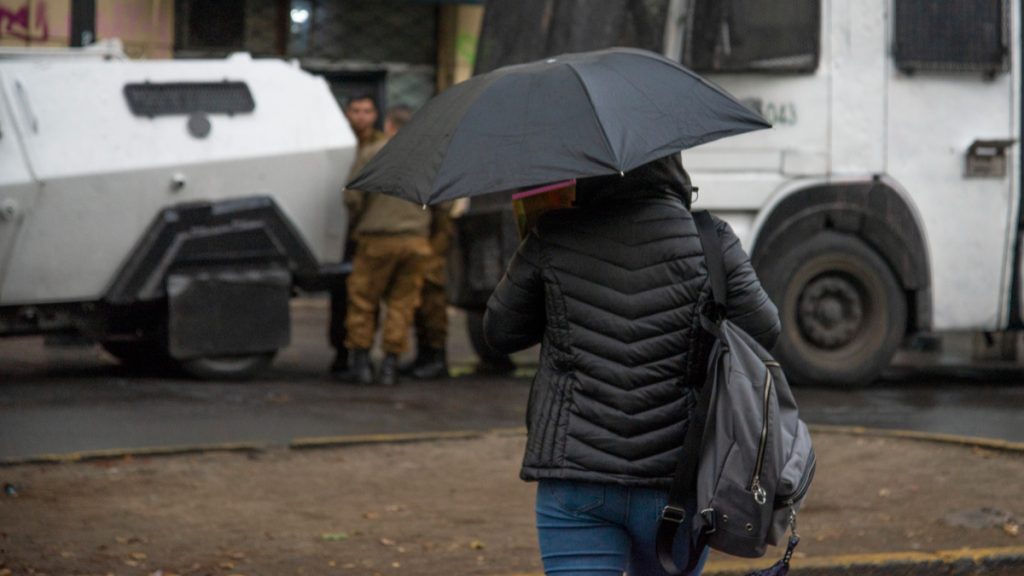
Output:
[{"xmin": 508, "ymin": 546, "xmax": 1024, "ymax": 576}]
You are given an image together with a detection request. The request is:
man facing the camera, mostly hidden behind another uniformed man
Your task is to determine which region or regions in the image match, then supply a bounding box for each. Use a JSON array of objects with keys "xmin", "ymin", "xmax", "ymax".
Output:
[{"xmin": 329, "ymin": 94, "xmax": 387, "ymax": 376}]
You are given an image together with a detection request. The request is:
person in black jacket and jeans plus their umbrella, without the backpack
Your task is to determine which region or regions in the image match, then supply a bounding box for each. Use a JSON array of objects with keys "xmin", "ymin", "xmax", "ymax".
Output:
[{"xmin": 352, "ymin": 49, "xmax": 779, "ymax": 576}]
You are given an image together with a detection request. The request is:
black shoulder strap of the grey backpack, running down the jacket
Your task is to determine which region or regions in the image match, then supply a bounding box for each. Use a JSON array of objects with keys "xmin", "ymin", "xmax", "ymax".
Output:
[{"xmin": 655, "ymin": 210, "xmax": 727, "ymax": 575}]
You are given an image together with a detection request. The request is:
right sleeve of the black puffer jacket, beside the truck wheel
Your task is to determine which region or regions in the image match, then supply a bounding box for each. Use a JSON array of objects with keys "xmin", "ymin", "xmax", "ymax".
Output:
[{"xmin": 715, "ymin": 218, "xmax": 781, "ymax": 349}]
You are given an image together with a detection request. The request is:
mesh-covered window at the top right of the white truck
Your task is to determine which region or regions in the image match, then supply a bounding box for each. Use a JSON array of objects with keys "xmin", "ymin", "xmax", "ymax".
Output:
[{"xmin": 893, "ymin": 0, "xmax": 1010, "ymax": 74}]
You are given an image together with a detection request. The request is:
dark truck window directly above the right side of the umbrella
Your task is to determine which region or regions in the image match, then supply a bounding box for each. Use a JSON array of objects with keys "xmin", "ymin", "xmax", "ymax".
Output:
[{"xmin": 682, "ymin": 0, "xmax": 821, "ymax": 73}]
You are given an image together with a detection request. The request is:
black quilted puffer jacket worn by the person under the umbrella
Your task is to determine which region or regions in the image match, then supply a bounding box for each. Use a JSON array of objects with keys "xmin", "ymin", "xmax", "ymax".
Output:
[{"xmin": 484, "ymin": 155, "xmax": 779, "ymax": 486}]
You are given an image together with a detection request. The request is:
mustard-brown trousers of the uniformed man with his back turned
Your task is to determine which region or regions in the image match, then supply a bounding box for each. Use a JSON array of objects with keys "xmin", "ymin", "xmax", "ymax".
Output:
[{"xmin": 345, "ymin": 236, "xmax": 430, "ymax": 355}]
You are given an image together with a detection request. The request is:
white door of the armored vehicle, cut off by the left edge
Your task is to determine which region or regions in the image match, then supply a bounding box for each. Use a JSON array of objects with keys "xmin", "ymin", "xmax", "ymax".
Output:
[{"xmin": 0, "ymin": 76, "xmax": 37, "ymax": 305}]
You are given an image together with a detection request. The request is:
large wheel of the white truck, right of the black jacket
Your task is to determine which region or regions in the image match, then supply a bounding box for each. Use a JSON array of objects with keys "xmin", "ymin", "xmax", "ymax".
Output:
[{"xmin": 760, "ymin": 232, "xmax": 906, "ymax": 387}]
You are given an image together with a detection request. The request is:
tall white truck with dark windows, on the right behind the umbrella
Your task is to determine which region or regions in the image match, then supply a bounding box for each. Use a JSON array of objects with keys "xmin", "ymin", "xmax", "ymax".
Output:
[{"xmin": 466, "ymin": 0, "xmax": 1024, "ymax": 386}]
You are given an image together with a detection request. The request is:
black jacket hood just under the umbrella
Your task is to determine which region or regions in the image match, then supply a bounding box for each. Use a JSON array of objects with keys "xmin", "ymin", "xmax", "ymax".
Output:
[{"xmin": 575, "ymin": 154, "xmax": 692, "ymax": 210}]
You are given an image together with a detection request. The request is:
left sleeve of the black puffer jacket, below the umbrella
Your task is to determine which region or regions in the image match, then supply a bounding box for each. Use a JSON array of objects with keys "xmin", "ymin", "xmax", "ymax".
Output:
[{"xmin": 483, "ymin": 234, "xmax": 545, "ymax": 354}]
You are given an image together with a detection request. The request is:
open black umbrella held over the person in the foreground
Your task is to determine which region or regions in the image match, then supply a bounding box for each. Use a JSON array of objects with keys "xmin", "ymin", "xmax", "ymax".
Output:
[{"xmin": 348, "ymin": 48, "xmax": 771, "ymax": 204}]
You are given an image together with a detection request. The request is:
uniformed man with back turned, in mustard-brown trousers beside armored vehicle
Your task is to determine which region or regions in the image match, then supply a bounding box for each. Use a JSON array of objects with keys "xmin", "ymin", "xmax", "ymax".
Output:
[{"xmin": 340, "ymin": 108, "xmax": 443, "ymax": 385}]
